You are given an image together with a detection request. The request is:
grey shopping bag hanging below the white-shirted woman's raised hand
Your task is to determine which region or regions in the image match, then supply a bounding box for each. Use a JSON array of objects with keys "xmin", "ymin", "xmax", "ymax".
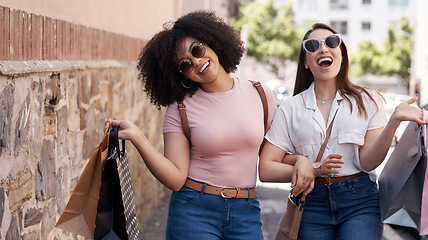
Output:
[{"xmin": 379, "ymin": 122, "xmax": 426, "ymax": 229}]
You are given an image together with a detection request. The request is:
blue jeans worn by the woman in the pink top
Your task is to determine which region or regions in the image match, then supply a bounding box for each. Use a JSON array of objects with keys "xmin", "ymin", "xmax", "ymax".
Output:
[{"xmin": 166, "ymin": 187, "xmax": 263, "ymax": 240}]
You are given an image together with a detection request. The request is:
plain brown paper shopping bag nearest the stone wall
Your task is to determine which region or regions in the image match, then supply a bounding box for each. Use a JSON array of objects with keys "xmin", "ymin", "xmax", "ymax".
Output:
[{"xmin": 56, "ymin": 129, "xmax": 109, "ymax": 238}]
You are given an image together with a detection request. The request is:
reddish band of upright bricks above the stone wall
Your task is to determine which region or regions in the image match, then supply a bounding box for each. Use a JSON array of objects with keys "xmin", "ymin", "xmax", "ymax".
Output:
[{"xmin": 0, "ymin": 7, "xmax": 144, "ymax": 61}]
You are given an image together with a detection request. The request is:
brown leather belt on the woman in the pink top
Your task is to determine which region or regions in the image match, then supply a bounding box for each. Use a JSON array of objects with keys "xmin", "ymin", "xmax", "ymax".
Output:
[{"xmin": 184, "ymin": 178, "xmax": 257, "ymax": 198}]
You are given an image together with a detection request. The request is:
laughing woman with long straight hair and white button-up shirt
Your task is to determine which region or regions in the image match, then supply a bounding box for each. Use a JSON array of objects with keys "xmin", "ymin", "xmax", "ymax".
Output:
[{"xmin": 259, "ymin": 23, "xmax": 427, "ymax": 240}]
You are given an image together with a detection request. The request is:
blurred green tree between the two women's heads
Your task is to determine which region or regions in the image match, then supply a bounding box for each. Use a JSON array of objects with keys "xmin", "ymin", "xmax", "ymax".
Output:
[{"xmin": 231, "ymin": 0, "xmax": 303, "ymax": 78}]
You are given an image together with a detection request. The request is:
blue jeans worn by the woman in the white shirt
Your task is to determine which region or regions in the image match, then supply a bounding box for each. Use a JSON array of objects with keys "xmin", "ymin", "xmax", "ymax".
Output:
[{"xmin": 298, "ymin": 175, "xmax": 383, "ymax": 240}]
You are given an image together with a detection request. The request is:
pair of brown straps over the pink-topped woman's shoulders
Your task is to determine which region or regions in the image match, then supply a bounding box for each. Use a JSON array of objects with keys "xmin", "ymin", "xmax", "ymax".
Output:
[{"xmin": 177, "ymin": 80, "xmax": 268, "ymax": 145}]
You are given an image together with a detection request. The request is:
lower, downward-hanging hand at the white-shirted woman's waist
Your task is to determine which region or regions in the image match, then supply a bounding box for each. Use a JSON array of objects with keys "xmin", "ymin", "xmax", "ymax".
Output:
[{"xmin": 290, "ymin": 156, "xmax": 315, "ymax": 196}]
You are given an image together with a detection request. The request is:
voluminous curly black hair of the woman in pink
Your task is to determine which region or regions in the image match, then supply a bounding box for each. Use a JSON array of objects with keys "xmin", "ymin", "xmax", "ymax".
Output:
[{"xmin": 137, "ymin": 11, "xmax": 245, "ymax": 108}]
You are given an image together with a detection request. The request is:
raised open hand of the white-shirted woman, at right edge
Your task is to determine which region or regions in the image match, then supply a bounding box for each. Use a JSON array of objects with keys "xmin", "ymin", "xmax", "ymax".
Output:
[{"xmin": 391, "ymin": 97, "xmax": 428, "ymax": 125}]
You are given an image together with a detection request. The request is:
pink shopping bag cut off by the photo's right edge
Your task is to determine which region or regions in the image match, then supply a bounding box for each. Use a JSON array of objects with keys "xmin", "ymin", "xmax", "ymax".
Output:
[{"xmin": 419, "ymin": 110, "xmax": 428, "ymax": 236}]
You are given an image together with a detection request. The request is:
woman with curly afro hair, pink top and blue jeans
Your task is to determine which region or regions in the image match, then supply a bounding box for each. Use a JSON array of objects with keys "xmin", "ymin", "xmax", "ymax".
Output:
[{"xmin": 106, "ymin": 11, "xmax": 276, "ymax": 240}]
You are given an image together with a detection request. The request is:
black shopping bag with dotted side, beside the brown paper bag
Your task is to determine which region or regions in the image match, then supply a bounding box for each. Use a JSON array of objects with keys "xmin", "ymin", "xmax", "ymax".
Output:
[{"xmin": 94, "ymin": 127, "xmax": 139, "ymax": 240}]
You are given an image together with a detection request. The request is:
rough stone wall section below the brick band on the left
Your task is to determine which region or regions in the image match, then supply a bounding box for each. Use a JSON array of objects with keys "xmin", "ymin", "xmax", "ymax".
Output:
[{"xmin": 0, "ymin": 61, "xmax": 165, "ymax": 240}]
